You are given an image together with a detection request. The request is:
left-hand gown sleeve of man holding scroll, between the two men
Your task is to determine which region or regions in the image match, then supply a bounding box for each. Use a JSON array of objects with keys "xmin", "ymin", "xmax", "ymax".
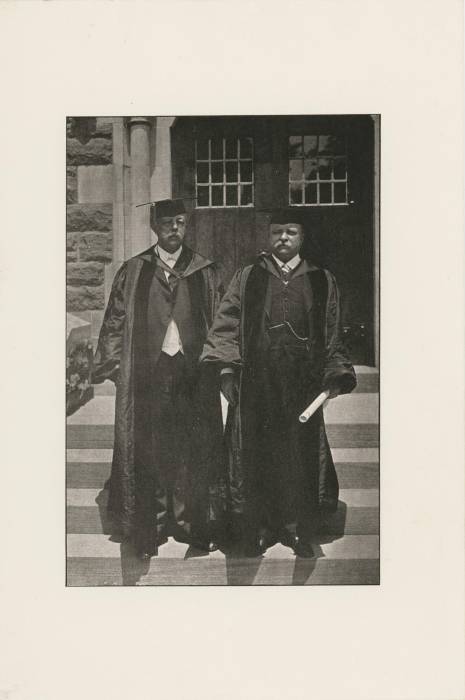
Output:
[{"xmin": 200, "ymin": 270, "xmax": 241, "ymax": 368}]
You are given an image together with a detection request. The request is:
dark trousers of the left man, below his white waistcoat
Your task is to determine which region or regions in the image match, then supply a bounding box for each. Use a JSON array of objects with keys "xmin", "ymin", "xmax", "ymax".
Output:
[{"xmin": 136, "ymin": 352, "xmax": 195, "ymax": 549}]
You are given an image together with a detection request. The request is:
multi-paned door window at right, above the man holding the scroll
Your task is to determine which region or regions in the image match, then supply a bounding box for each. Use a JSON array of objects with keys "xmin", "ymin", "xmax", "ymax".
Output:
[{"xmin": 289, "ymin": 134, "xmax": 348, "ymax": 207}]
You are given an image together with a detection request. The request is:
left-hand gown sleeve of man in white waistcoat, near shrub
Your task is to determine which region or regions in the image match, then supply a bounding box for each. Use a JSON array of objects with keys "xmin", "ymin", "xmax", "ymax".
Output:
[{"xmin": 92, "ymin": 264, "xmax": 127, "ymax": 384}]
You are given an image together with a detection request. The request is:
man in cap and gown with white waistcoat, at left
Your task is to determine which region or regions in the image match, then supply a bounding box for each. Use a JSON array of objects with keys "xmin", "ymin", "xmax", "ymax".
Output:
[{"xmin": 93, "ymin": 199, "xmax": 226, "ymax": 559}]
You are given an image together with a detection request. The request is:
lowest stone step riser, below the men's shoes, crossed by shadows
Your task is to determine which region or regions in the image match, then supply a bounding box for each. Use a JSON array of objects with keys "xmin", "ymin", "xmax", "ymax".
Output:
[{"xmin": 67, "ymin": 550, "xmax": 380, "ymax": 586}]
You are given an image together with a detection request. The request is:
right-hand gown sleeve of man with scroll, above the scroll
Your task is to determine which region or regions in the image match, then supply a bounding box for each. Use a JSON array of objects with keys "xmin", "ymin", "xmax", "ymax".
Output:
[{"xmin": 323, "ymin": 273, "xmax": 357, "ymax": 394}]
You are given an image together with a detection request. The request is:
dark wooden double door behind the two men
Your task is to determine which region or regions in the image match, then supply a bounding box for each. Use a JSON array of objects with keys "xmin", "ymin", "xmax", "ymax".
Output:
[{"xmin": 172, "ymin": 115, "xmax": 374, "ymax": 364}]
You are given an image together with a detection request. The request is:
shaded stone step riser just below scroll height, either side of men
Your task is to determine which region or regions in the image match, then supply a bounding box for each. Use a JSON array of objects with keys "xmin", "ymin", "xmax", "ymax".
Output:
[{"xmin": 66, "ymin": 423, "xmax": 379, "ymax": 449}]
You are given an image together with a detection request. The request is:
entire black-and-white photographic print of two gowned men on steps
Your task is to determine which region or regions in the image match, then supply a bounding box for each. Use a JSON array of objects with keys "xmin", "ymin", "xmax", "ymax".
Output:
[{"xmin": 66, "ymin": 114, "xmax": 380, "ymax": 586}]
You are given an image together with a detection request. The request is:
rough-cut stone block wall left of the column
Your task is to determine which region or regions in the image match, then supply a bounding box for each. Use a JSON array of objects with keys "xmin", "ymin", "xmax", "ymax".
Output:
[{"xmin": 66, "ymin": 117, "xmax": 114, "ymax": 326}]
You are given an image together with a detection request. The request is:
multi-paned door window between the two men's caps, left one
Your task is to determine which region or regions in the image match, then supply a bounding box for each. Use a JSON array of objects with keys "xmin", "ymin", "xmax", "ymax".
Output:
[{"xmin": 195, "ymin": 136, "xmax": 254, "ymax": 209}]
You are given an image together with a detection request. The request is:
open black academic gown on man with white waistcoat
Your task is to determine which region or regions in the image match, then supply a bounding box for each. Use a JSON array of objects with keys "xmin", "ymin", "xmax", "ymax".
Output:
[{"xmin": 93, "ymin": 246, "xmax": 224, "ymax": 539}]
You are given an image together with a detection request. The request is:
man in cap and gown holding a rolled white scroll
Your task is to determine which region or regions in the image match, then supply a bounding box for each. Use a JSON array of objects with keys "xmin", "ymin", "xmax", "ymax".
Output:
[{"xmin": 201, "ymin": 208, "xmax": 356, "ymax": 557}]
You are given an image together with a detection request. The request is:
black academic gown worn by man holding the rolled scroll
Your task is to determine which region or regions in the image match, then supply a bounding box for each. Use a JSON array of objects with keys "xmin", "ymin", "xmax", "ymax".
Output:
[{"xmin": 201, "ymin": 255, "xmax": 356, "ymax": 534}]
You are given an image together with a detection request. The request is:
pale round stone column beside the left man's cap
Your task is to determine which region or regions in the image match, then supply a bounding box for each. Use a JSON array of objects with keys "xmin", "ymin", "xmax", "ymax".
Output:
[{"xmin": 125, "ymin": 117, "xmax": 152, "ymax": 257}]
